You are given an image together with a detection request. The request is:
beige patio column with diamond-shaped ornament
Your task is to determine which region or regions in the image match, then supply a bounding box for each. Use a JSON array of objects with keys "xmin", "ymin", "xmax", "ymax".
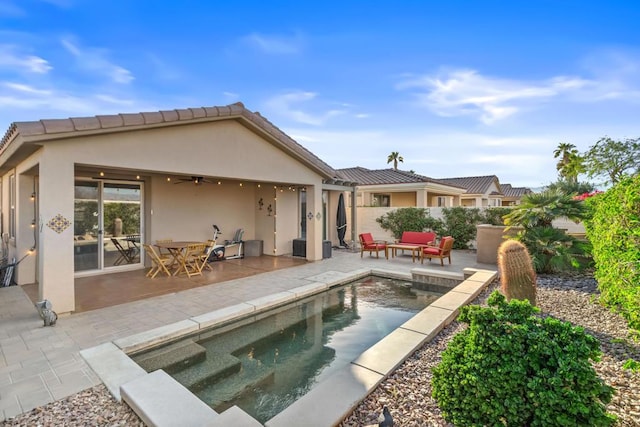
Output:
[{"xmin": 37, "ymin": 154, "xmax": 75, "ymax": 314}]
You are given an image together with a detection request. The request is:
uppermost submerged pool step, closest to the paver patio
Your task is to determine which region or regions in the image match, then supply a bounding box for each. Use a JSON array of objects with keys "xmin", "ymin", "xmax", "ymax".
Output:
[{"xmin": 133, "ymin": 340, "xmax": 207, "ymax": 374}]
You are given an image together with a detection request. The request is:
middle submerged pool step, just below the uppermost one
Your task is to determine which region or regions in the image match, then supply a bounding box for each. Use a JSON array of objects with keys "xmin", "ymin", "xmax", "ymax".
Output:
[{"xmin": 173, "ymin": 352, "xmax": 241, "ymax": 390}]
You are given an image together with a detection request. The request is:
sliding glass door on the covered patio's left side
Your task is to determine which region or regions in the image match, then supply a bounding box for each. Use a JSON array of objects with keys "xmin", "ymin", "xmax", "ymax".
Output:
[{"xmin": 74, "ymin": 180, "xmax": 143, "ymax": 272}]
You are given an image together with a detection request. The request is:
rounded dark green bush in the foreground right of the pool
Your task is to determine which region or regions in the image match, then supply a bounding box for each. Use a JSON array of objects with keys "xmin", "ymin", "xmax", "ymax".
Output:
[{"xmin": 432, "ymin": 291, "xmax": 615, "ymax": 426}]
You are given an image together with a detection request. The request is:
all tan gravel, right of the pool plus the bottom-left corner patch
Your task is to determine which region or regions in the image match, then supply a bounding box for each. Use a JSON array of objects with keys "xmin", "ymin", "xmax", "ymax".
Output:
[{"xmin": 3, "ymin": 276, "xmax": 640, "ymax": 427}]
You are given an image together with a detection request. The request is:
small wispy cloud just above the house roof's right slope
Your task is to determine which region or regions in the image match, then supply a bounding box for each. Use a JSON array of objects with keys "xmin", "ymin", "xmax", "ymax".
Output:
[{"xmin": 266, "ymin": 91, "xmax": 346, "ymax": 126}]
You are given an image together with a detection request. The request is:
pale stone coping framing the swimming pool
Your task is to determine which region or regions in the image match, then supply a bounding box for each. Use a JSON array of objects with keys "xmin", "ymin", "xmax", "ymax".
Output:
[{"xmin": 80, "ymin": 268, "xmax": 497, "ymax": 427}]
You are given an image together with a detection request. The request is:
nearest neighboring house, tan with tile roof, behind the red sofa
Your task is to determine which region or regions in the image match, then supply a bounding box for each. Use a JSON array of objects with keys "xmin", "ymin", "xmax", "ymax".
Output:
[{"xmin": 337, "ymin": 167, "xmax": 466, "ymax": 208}]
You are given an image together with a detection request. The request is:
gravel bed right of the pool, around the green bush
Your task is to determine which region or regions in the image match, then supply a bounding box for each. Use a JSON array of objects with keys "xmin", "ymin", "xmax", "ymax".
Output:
[{"xmin": 341, "ymin": 275, "xmax": 640, "ymax": 427}]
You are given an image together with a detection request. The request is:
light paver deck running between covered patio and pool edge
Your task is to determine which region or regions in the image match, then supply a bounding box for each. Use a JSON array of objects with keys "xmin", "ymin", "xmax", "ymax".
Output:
[{"xmin": 0, "ymin": 251, "xmax": 495, "ymax": 425}]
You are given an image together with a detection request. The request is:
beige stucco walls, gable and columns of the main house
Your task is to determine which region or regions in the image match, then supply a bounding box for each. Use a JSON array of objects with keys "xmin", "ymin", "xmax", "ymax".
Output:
[{"xmin": 7, "ymin": 121, "xmax": 330, "ymax": 313}]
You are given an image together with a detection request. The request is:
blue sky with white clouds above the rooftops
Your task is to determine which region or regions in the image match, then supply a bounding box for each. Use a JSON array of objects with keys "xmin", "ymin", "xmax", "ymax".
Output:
[{"xmin": 0, "ymin": 0, "xmax": 640, "ymax": 187}]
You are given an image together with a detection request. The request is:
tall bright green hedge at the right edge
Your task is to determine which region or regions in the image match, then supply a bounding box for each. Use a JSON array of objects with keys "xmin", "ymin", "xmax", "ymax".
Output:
[{"xmin": 585, "ymin": 175, "xmax": 640, "ymax": 329}]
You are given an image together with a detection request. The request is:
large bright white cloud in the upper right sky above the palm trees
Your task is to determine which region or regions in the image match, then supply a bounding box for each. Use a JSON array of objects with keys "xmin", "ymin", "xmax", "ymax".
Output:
[{"xmin": 397, "ymin": 70, "xmax": 594, "ymax": 124}]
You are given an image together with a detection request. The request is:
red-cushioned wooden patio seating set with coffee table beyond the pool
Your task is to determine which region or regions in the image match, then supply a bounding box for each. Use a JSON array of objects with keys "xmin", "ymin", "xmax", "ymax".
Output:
[{"xmin": 359, "ymin": 231, "xmax": 454, "ymax": 266}]
